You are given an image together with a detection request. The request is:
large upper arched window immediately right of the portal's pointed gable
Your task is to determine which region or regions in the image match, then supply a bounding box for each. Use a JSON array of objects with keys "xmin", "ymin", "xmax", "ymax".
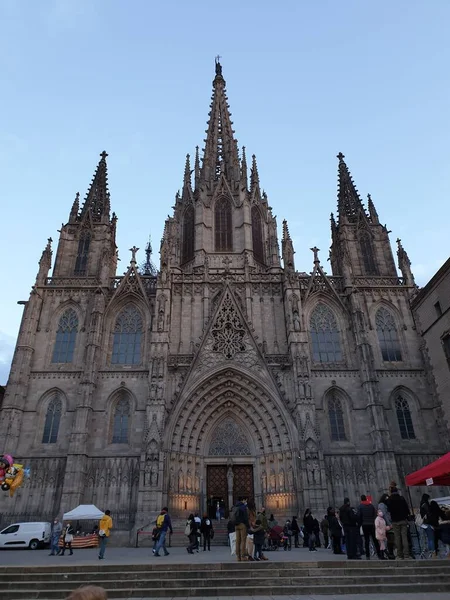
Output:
[{"xmin": 310, "ymin": 304, "xmax": 342, "ymax": 363}]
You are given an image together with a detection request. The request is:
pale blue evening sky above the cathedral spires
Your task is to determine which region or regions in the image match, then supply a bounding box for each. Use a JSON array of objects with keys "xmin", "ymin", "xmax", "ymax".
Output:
[{"xmin": 0, "ymin": 0, "xmax": 450, "ymax": 383}]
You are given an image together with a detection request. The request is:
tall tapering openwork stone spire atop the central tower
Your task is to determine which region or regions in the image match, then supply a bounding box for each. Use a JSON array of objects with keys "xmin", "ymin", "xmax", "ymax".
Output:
[{"xmin": 201, "ymin": 56, "xmax": 240, "ymax": 182}]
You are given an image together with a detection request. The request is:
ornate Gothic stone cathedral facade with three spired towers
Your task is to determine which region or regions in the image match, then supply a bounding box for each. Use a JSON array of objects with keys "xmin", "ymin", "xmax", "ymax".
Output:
[{"xmin": 0, "ymin": 63, "xmax": 448, "ymax": 537}]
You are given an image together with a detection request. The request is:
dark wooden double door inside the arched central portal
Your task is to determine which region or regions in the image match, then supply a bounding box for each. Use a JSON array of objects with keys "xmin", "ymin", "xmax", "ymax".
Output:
[{"xmin": 206, "ymin": 465, "xmax": 255, "ymax": 517}]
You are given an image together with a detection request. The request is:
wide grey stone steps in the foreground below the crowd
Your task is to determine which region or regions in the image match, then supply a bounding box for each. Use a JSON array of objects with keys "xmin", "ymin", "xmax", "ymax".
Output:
[{"xmin": 0, "ymin": 560, "xmax": 450, "ymax": 600}]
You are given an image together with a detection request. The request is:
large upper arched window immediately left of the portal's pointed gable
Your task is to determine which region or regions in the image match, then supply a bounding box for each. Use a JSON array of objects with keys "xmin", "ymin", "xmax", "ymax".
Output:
[{"xmin": 111, "ymin": 304, "xmax": 143, "ymax": 365}]
